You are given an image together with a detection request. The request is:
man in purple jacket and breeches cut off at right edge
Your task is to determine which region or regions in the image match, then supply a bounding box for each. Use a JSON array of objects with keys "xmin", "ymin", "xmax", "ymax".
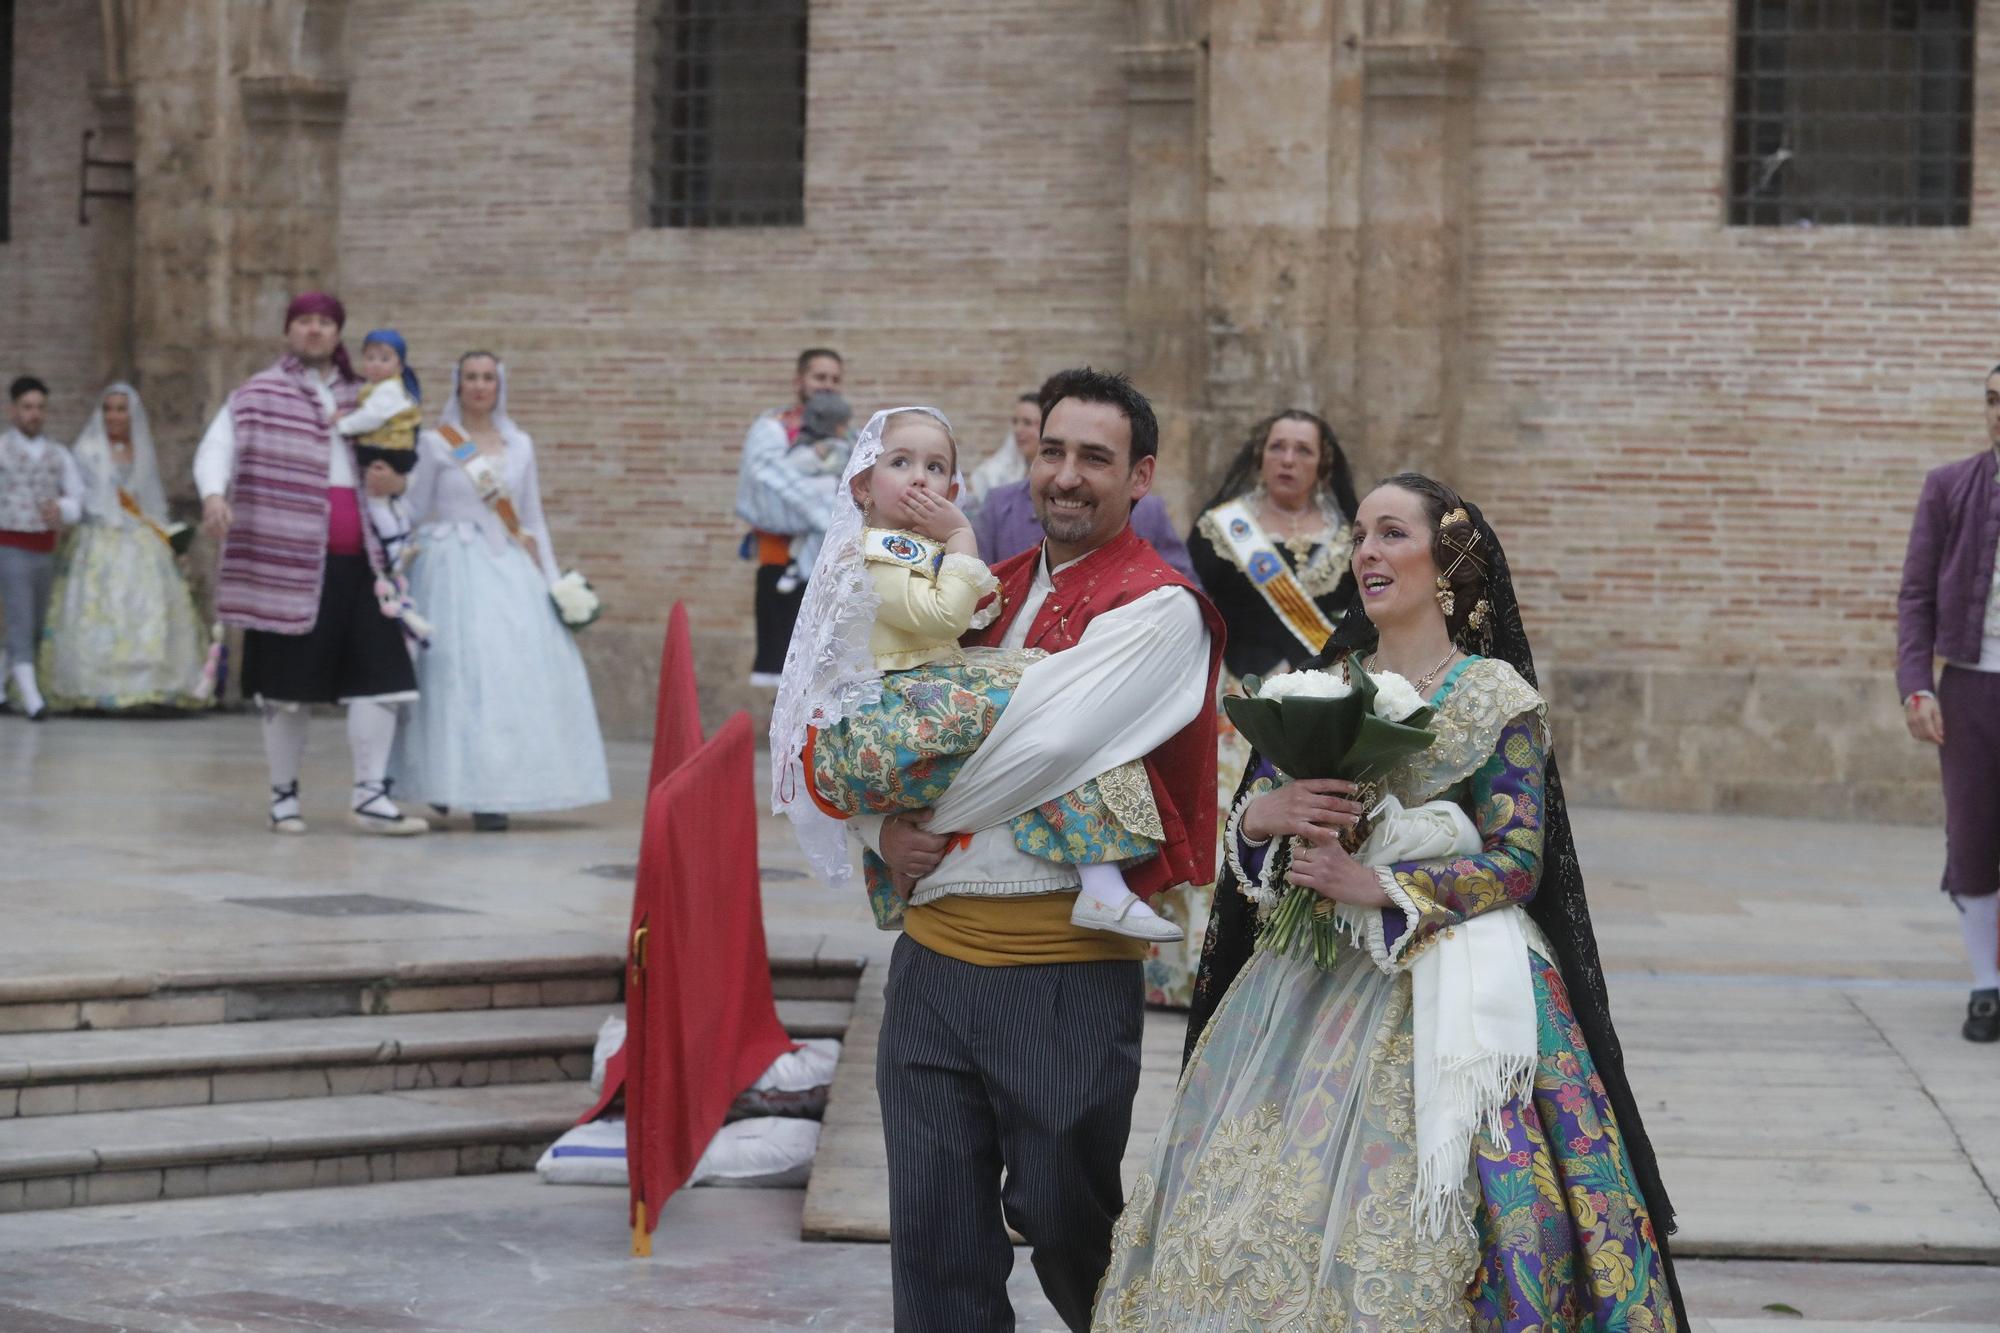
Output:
[{"xmin": 1896, "ymin": 366, "xmax": 2000, "ymax": 1041}]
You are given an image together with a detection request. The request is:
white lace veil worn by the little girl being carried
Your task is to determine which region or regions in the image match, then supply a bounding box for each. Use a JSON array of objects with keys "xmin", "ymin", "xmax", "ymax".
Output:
[{"xmin": 770, "ymin": 406, "xmax": 952, "ymax": 885}]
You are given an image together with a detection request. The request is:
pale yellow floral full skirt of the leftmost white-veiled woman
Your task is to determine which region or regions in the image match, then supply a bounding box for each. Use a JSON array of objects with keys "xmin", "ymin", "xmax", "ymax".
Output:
[{"xmin": 36, "ymin": 454, "xmax": 208, "ymax": 713}]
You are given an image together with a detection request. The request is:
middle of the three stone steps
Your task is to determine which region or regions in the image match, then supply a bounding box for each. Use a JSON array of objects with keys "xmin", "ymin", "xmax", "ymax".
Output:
[{"xmin": 0, "ymin": 1001, "xmax": 852, "ymax": 1119}]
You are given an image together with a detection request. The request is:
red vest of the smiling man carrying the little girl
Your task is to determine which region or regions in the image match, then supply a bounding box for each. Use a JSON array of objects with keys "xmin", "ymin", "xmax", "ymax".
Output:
[{"xmin": 966, "ymin": 524, "xmax": 1222, "ymax": 899}]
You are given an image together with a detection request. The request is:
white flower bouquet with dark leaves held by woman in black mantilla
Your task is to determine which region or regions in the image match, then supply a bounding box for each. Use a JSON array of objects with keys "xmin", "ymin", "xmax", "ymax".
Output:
[{"xmin": 1222, "ymin": 654, "xmax": 1434, "ymax": 967}]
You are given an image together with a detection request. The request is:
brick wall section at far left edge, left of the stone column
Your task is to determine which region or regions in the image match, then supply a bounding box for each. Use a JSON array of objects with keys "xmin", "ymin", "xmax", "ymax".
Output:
[{"xmin": 0, "ymin": 0, "xmax": 117, "ymax": 440}]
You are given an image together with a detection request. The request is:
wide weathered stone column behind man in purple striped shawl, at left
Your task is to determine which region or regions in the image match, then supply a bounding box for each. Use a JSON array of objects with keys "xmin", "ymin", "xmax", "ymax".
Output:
[{"xmin": 119, "ymin": 0, "xmax": 346, "ymax": 496}]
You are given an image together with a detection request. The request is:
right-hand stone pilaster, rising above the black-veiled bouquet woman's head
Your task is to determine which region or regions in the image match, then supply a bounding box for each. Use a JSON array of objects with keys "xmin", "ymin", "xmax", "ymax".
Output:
[{"xmin": 1352, "ymin": 0, "xmax": 1478, "ymax": 476}]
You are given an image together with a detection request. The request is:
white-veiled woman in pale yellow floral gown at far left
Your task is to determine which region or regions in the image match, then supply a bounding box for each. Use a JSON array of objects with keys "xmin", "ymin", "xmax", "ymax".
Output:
[{"xmin": 40, "ymin": 382, "xmax": 208, "ymax": 713}]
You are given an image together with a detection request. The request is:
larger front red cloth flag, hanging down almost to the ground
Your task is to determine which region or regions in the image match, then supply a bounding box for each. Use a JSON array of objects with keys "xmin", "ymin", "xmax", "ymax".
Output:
[{"xmin": 626, "ymin": 713, "xmax": 794, "ymax": 1255}]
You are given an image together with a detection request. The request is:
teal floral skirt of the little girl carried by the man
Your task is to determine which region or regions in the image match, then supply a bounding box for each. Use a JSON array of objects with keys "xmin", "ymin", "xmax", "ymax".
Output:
[{"xmin": 808, "ymin": 648, "xmax": 1160, "ymax": 865}]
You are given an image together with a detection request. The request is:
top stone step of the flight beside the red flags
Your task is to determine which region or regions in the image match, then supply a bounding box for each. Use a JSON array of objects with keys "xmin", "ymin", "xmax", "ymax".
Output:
[{"xmin": 0, "ymin": 955, "xmax": 860, "ymax": 1033}]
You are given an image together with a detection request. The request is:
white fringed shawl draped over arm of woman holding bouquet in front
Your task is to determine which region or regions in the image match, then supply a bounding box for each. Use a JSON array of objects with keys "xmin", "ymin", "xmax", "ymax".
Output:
[{"xmin": 1340, "ymin": 797, "xmax": 1540, "ymax": 1237}]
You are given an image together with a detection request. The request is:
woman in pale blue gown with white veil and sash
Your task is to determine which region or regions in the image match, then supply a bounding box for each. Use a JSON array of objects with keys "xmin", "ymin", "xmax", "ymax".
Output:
[{"xmin": 392, "ymin": 352, "xmax": 610, "ymax": 833}]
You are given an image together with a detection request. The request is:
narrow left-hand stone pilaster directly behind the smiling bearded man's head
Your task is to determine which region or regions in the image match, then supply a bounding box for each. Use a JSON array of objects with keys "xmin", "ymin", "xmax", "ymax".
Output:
[{"xmin": 1118, "ymin": 0, "xmax": 1210, "ymax": 526}]
